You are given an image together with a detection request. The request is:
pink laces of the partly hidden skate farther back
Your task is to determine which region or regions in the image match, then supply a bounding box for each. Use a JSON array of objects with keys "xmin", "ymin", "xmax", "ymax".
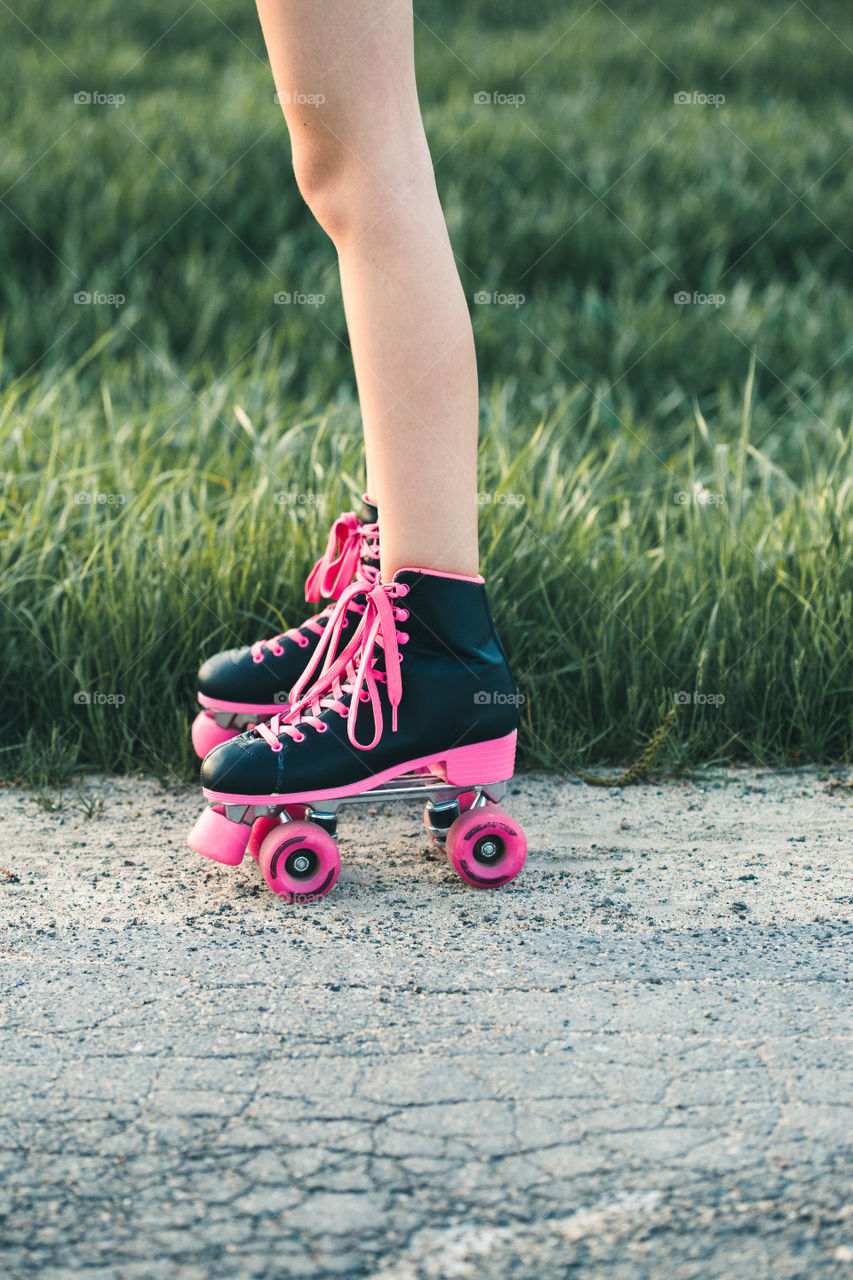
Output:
[{"xmin": 251, "ymin": 511, "xmax": 379, "ymax": 663}]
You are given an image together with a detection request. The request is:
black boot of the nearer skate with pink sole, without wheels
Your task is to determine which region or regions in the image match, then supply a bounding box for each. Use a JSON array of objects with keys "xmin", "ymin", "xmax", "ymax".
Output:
[{"xmin": 201, "ymin": 568, "xmax": 517, "ymax": 804}]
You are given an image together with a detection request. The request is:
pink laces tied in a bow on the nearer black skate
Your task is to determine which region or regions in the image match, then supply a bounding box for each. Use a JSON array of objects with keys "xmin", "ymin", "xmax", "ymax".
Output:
[{"xmin": 256, "ymin": 582, "xmax": 409, "ymax": 751}]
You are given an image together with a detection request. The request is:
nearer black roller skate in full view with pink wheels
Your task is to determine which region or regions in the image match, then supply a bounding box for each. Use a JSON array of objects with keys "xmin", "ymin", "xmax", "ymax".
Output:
[{"xmin": 188, "ymin": 568, "xmax": 526, "ymax": 902}]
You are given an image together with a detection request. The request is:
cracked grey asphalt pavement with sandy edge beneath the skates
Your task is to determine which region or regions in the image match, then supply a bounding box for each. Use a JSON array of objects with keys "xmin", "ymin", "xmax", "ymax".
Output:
[{"xmin": 0, "ymin": 768, "xmax": 853, "ymax": 1280}]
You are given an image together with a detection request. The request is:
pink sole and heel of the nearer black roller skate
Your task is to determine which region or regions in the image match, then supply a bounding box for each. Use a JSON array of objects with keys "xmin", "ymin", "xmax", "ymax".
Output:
[{"xmin": 202, "ymin": 730, "xmax": 517, "ymax": 804}]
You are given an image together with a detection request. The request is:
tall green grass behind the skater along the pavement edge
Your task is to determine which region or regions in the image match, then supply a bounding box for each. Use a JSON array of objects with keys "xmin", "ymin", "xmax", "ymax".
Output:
[{"xmin": 0, "ymin": 0, "xmax": 853, "ymax": 786}]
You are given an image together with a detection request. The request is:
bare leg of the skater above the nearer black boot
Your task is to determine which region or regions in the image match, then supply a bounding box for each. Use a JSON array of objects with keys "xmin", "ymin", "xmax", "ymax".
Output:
[{"xmin": 257, "ymin": 0, "xmax": 479, "ymax": 581}]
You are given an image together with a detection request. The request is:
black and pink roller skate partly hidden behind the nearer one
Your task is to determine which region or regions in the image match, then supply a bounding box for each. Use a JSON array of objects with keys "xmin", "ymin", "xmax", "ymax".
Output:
[{"xmin": 192, "ymin": 498, "xmax": 379, "ymax": 759}]
